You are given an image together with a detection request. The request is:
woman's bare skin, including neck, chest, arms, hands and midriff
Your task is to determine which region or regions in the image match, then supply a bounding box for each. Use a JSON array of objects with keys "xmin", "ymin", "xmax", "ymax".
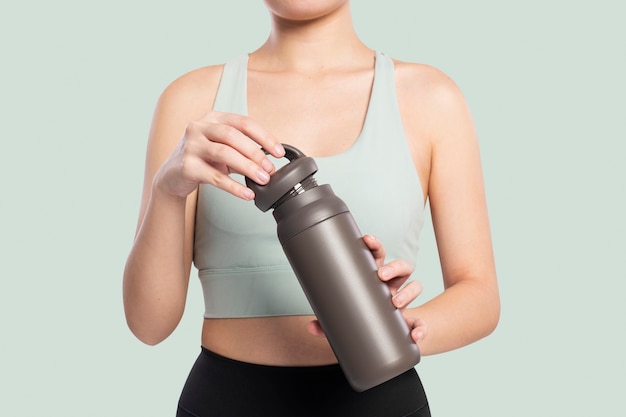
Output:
[{"xmin": 123, "ymin": 0, "xmax": 500, "ymax": 365}]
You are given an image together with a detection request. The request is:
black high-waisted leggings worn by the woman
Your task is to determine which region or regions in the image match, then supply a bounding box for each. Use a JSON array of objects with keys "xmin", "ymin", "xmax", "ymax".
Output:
[{"xmin": 176, "ymin": 348, "xmax": 430, "ymax": 417}]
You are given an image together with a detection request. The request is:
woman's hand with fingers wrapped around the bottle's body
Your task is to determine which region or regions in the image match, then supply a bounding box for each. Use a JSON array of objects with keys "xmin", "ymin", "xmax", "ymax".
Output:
[{"xmin": 308, "ymin": 235, "xmax": 426, "ymax": 343}]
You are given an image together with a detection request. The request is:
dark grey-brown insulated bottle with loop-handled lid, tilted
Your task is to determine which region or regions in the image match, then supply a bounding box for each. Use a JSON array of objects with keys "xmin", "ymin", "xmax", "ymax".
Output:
[{"xmin": 246, "ymin": 145, "xmax": 420, "ymax": 391}]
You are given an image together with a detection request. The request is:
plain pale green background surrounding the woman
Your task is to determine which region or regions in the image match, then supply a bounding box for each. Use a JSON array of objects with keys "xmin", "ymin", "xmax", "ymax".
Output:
[{"xmin": 0, "ymin": 0, "xmax": 626, "ymax": 417}]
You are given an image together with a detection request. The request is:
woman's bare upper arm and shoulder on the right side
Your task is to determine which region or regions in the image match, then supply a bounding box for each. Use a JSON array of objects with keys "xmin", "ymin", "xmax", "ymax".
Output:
[{"xmin": 398, "ymin": 62, "xmax": 495, "ymax": 287}]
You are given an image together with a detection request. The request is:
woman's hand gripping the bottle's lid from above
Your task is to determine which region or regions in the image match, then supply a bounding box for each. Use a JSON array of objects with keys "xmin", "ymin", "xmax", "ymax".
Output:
[{"xmin": 153, "ymin": 111, "xmax": 285, "ymax": 200}]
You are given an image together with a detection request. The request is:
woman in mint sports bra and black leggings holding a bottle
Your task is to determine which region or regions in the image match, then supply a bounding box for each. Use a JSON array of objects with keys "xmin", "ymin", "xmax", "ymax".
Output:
[{"xmin": 124, "ymin": 0, "xmax": 499, "ymax": 417}]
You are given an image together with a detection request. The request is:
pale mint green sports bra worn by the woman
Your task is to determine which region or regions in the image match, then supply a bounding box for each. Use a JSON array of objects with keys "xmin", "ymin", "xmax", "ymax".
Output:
[{"xmin": 194, "ymin": 52, "xmax": 424, "ymax": 318}]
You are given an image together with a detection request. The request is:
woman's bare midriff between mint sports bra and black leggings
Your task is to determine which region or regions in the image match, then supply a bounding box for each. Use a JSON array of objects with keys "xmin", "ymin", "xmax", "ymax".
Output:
[{"xmin": 202, "ymin": 316, "xmax": 337, "ymax": 366}]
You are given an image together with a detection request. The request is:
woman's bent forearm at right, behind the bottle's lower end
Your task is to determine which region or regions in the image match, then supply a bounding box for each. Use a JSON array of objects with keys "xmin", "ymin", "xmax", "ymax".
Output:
[{"xmin": 405, "ymin": 279, "xmax": 500, "ymax": 356}]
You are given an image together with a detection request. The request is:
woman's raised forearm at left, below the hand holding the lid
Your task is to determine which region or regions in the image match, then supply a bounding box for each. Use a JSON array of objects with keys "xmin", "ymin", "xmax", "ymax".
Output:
[{"xmin": 124, "ymin": 187, "xmax": 189, "ymax": 344}]
